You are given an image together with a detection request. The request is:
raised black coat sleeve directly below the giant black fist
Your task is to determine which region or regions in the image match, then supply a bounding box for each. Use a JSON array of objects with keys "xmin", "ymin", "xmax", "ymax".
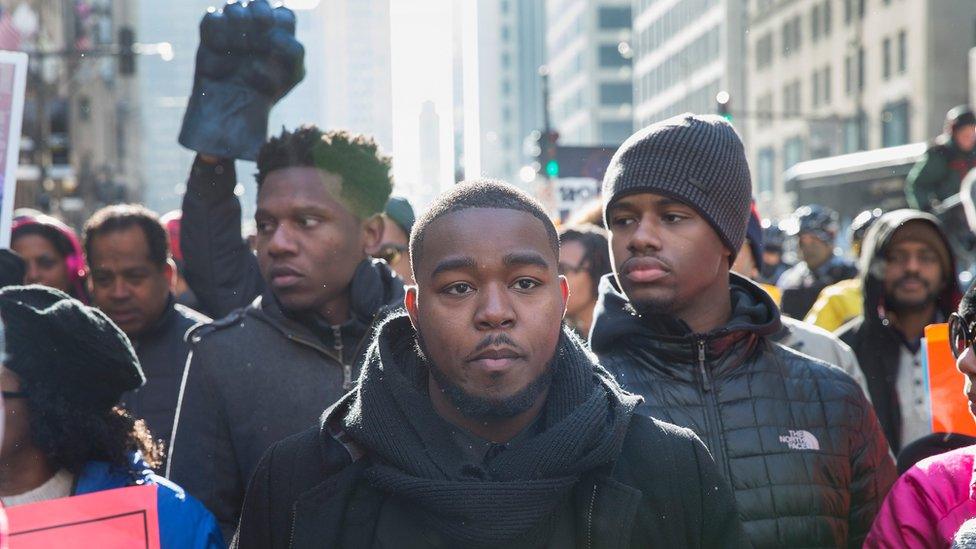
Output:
[{"xmin": 180, "ymin": 157, "xmax": 264, "ymax": 319}]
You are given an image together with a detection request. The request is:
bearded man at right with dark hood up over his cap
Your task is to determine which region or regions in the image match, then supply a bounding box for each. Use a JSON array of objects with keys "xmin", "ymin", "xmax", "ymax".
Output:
[{"xmin": 838, "ymin": 210, "xmax": 960, "ymax": 453}]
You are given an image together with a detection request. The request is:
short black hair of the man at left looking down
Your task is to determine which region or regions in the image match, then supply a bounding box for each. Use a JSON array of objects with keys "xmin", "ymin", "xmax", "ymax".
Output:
[{"xmin": 82, "ymin": 204, "xmax": 169, "ymax": 268}]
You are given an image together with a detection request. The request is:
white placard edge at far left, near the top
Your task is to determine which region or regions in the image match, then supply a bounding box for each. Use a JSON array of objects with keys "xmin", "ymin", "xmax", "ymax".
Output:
[{"xmin": 0, "ymin": 51, "xmax": 27, "ymax": 248}]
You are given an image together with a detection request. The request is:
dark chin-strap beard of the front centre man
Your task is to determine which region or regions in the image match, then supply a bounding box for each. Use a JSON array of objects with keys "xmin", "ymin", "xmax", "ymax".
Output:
[{"xmin": 417, "ymin": 332, "xmax": 559, "ymax": 421}]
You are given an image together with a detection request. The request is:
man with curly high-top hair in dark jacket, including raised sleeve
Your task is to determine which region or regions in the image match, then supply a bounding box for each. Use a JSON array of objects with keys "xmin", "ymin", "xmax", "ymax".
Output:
[{"xmin": 167, "ymin": 126, "xmax": 403, "ymax": 539}]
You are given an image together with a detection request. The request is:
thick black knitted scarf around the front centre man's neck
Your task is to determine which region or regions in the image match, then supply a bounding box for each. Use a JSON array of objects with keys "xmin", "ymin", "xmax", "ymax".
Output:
[{"xmin": 343, "ymin": 314, "xmax": 640, "ymax": 545}]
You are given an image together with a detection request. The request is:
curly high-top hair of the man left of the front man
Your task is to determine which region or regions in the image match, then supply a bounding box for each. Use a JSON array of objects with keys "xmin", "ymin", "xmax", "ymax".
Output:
[{"xmin": 264, "ymin": 125, "xmax": 393, "ymax": 219}]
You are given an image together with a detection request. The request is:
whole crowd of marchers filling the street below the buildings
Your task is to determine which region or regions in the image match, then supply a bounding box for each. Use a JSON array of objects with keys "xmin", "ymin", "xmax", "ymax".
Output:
[{"xmin": 9, "ymin": 0, "xmax": 976, "ymax": 549}]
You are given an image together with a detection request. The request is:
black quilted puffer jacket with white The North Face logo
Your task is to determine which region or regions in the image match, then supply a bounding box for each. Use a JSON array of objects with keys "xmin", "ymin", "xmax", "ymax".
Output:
[{"xmin": 590, "ymin": 274, "xmax": 896, "ymax": 547}]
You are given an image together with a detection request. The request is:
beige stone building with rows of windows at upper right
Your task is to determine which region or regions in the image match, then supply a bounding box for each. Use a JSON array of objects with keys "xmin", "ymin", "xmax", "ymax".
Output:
[{"xmin": 748, "ymin": 0, "xmax": 976, "ymax": 216}]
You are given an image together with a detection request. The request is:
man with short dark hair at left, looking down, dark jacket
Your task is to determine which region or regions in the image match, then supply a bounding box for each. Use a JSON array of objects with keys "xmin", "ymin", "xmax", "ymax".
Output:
[{"xmin": 83, "ymin": 205, "xmax": 210, "ymax": 454}]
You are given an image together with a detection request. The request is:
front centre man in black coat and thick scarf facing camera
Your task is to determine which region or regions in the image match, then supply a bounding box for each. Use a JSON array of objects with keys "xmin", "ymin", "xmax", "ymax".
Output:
[{"xmin": 236, "ymin": 182, "xmax": 741, "ymax": 549}]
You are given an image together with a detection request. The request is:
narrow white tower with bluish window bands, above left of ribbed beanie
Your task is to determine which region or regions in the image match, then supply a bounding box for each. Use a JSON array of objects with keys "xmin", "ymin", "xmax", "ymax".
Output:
[{"xmin": 546, "ymin": 0, "xmax": 634, "ymax": 145}]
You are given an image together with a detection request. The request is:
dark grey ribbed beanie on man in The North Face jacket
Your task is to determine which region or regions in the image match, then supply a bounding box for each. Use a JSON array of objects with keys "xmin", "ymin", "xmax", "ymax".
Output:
[{"xmin": 603, "ymin": 113, "xmax": 752, "ymax": 259}]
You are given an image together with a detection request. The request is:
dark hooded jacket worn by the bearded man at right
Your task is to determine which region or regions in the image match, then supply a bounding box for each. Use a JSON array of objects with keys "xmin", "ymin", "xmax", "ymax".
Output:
[{"xmin": 837, "ymin": 210, "xmax": 962, "ymax": 452}]
